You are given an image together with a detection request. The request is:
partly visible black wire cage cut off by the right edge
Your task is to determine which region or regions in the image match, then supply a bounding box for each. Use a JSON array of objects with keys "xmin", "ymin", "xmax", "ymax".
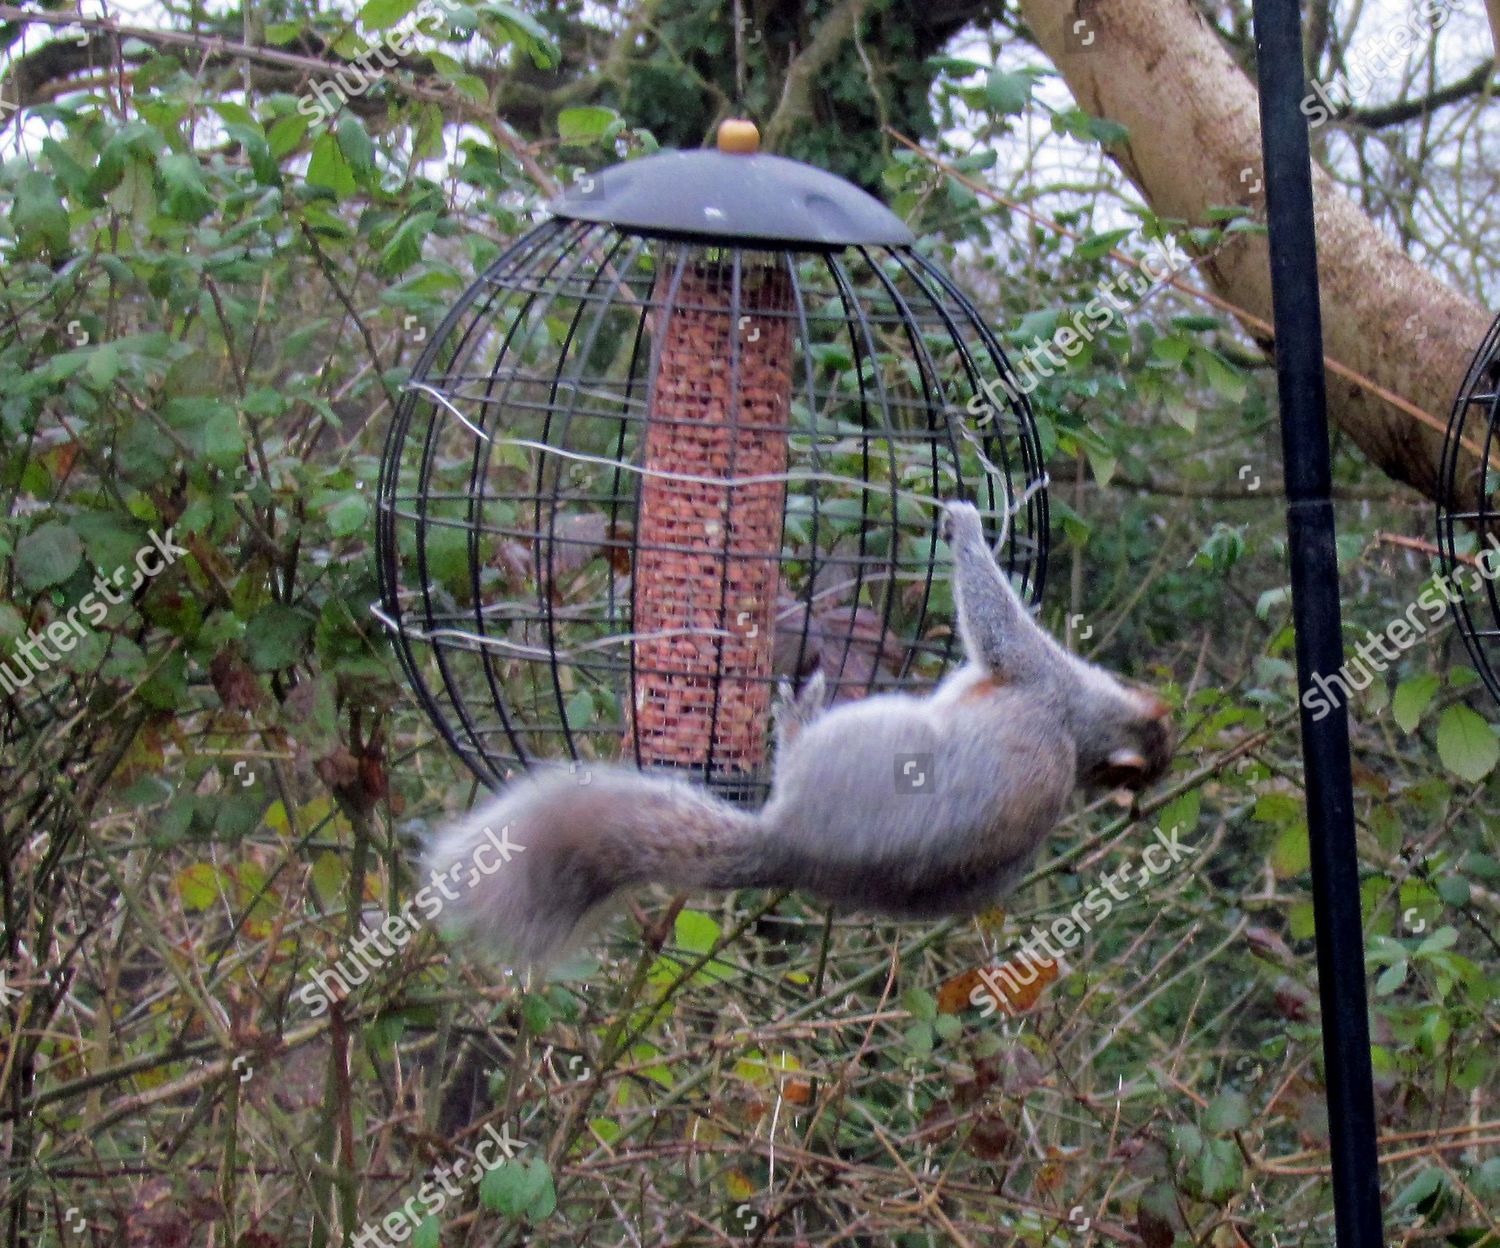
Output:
[{"xmin": 1437, "ymin": 317, "xmax": 1500, "ymax": 702}]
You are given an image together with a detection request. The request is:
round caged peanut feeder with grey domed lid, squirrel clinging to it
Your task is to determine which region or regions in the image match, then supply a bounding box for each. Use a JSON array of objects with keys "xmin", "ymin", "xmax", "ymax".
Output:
[{"xmin": 375, "ymin": 123, "xmax": 1047, "ymax": 803}]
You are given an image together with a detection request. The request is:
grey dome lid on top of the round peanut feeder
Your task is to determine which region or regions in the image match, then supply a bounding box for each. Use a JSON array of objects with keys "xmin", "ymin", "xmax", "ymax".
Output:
[{"xmin": 548, "ymin": 149, "xmax": 915, "ymax": 248}]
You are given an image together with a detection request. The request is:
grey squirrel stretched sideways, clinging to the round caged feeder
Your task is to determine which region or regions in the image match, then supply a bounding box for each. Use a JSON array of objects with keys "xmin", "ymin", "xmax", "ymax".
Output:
[{"xmin": 426, "ymin": 503, "xmax": 1173, "ymax": 965}]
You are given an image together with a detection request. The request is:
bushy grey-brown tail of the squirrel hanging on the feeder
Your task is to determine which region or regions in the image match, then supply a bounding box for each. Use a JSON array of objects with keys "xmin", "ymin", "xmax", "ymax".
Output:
[{"xmin": 425, "ymin": 764, "xmax": 774, "ymax": 966}]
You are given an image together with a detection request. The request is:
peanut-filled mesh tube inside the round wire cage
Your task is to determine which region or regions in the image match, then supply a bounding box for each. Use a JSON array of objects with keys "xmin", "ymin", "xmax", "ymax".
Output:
[{"xmin": 627, "ymin": 252, "xmax": 792, "ymax": 779}]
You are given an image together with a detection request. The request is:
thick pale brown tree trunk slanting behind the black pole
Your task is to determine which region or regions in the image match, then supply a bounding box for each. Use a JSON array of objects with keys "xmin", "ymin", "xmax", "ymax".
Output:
[{"xmin": 1022, "ymin": 0, "xmax": 1494, "ymax": 503}]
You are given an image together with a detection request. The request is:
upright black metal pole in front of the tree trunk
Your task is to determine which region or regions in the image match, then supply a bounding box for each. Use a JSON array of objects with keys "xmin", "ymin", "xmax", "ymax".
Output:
[{"xmin": 1254, "ymin": 0, "xmax": 1383, "ymax": 1248}]
